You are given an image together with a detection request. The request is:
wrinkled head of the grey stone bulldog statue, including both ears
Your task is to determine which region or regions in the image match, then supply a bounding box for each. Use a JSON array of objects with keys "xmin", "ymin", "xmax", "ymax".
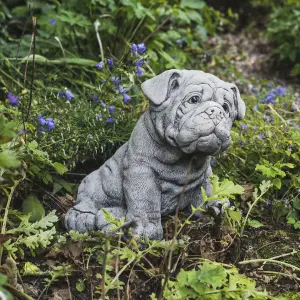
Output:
[{"xmin": 142, "ymin": 70, "xmax": 245, "ymax": 155}]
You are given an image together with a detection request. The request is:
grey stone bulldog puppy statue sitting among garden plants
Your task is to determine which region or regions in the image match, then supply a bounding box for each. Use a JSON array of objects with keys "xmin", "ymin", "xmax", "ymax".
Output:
[{"xmin": 65, "ymin": 69, "xmax": 246, "ymax": 239}]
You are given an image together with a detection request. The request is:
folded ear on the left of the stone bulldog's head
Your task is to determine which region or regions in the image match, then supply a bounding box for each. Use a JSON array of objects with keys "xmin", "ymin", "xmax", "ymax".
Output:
[{"xmin": 141, "ymin": 69, "xmax": 180, "ymax": 106}]
